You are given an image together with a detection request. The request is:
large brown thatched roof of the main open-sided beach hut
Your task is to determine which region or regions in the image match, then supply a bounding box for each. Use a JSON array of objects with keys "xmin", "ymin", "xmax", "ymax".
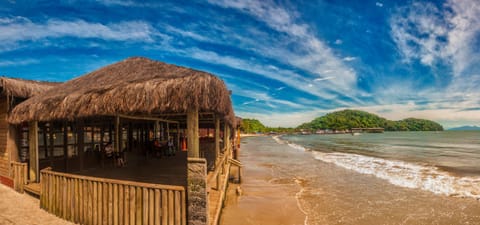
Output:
[{"xmin": 8, "ymin": 57, "xmax": 235, "ymax": 125}]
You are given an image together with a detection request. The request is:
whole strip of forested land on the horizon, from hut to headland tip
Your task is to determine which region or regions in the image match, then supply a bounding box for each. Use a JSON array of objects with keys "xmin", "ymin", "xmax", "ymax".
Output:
[{"xmin": 241, "ymin": 109, "xmax": 443, "ymax": 133}]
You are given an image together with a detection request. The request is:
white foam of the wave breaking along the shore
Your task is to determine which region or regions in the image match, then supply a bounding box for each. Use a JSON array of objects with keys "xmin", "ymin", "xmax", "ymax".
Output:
[{"xmin": 313, "ymin": 152, "xmax": 480, "ymax": 200}]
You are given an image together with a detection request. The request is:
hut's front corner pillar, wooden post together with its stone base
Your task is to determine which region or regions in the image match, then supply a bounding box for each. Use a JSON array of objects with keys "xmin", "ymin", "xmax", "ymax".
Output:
[{"xmin": 187, "ymin": 108, "xmax": 208, "ymax": 225}]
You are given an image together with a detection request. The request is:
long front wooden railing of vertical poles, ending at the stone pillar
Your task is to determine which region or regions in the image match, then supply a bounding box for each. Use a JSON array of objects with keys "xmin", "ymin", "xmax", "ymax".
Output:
[{"xmin": 40, "ymin": 168, "xmax": 187, "ymax": 225}]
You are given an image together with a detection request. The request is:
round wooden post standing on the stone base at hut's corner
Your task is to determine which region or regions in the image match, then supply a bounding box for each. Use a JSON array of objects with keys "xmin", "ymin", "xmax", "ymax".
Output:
[{"xmin": 187, "ymin": 108, "xmax": 200, "ymax": 158}]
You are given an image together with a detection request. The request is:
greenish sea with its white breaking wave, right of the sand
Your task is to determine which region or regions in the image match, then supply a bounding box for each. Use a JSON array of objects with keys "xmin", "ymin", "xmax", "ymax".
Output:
[{"xmin": 282, "ymin": 131, "xmax": 480, "ymax": 200}]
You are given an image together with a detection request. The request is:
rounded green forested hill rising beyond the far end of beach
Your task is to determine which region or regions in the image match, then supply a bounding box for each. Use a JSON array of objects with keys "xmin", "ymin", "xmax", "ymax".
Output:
[{"xmin": 298, "ymin": 109, "xmax": 443, "ymax": 131}]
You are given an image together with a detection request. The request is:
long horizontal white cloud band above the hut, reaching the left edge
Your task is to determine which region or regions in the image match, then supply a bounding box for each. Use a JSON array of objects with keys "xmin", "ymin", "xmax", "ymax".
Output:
[{"xmin": 0, "ymin": 17, "xmax": 162, "ymax": 49}]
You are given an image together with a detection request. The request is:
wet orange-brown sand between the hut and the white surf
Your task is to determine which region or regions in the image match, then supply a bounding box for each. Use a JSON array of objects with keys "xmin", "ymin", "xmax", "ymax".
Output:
[{"xmin": 222, "ymin": 137, "xmax": 480, "ymax": 225}]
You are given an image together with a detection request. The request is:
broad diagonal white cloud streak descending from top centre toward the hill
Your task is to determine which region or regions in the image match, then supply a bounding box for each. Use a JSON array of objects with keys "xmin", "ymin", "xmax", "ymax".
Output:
[{"xmin": 209, "ymin": 0, "xmax": 356, "ymax": 90}]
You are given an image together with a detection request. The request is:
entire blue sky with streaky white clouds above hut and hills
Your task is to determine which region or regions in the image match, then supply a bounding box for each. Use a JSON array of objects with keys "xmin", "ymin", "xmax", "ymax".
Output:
[{"xmin": 0, "ymin": 0, "xmax": 480, "ymax": 128}]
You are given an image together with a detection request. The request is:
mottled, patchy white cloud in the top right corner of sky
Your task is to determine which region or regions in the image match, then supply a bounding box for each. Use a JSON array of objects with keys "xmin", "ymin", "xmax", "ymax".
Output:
[{"xmin": 390, "ymin": 0, "xmax": 480, "ymax": 76}]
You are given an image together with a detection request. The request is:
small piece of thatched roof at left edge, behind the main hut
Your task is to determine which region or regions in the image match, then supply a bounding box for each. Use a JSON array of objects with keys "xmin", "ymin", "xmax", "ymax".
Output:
[{"xmin": 0, "ymin": 77, "xmax": 60, "ymax": 98}]
